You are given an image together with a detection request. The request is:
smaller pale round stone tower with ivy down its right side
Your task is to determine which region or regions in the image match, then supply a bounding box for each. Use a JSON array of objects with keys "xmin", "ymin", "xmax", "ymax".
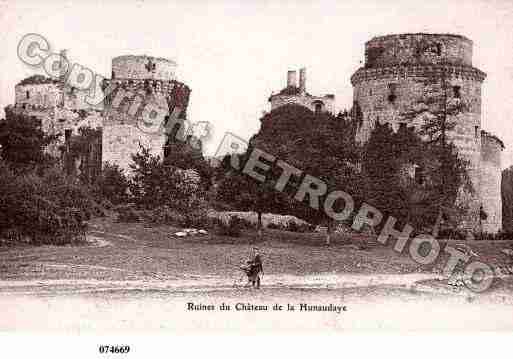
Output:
[{"xmin": 102, "ymin": 55, "xmax": 190, "ymax": 169}]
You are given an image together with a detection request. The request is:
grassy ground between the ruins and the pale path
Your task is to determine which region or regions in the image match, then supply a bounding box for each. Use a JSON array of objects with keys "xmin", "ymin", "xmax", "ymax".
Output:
[{"xmin": 0, "ymin": 218, "xmax": 512, "ymax": 286}]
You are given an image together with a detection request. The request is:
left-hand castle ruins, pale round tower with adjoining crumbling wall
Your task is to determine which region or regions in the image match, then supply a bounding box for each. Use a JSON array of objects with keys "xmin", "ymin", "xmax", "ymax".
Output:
[{"xmin": 8, "ymin": 52, "xmax": 190, "ymax": 177}]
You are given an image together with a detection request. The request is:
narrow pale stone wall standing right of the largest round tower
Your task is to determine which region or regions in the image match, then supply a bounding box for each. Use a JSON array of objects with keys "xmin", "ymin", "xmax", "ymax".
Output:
[{"xmin": 480, "ymin": 131, "xmax": 504, "ymax": 233}]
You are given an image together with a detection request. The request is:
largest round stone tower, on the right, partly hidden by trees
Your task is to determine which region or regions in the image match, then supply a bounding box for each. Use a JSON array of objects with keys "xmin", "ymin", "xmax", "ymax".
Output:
[{"xmin": 351, "ymin": 33, "xmax": 494, "ymax": 231}]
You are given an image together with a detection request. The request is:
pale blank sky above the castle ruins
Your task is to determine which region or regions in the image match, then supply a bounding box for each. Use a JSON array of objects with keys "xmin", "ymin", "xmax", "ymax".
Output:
[{"xmin": 0, "ymin": 0, "xmax": 513, "ymax": 168}]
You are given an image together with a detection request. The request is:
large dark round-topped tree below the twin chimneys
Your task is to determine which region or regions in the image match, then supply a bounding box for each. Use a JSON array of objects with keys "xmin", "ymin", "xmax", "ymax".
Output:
[{"xmin": 250, "ymin": 105, "xmax": 361, "ymax": 244}]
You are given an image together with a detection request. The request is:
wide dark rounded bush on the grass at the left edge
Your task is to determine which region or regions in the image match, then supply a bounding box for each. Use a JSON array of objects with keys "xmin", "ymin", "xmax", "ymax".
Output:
[{"xmin": 0, "ymin": 164, "xmax": 91, "ymax": 245}]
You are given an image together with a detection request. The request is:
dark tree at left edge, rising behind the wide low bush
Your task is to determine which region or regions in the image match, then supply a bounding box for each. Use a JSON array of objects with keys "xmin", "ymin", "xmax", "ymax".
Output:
[{"xmin": 0, "ymin": 108, "xmax": 57, "ymax": 168}]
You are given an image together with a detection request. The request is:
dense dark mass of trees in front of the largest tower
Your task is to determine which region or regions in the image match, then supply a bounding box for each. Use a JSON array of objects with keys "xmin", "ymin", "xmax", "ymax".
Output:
[{"xmin": 214, "ymin": 105, "xmax": 472, "ymax": 240}]
